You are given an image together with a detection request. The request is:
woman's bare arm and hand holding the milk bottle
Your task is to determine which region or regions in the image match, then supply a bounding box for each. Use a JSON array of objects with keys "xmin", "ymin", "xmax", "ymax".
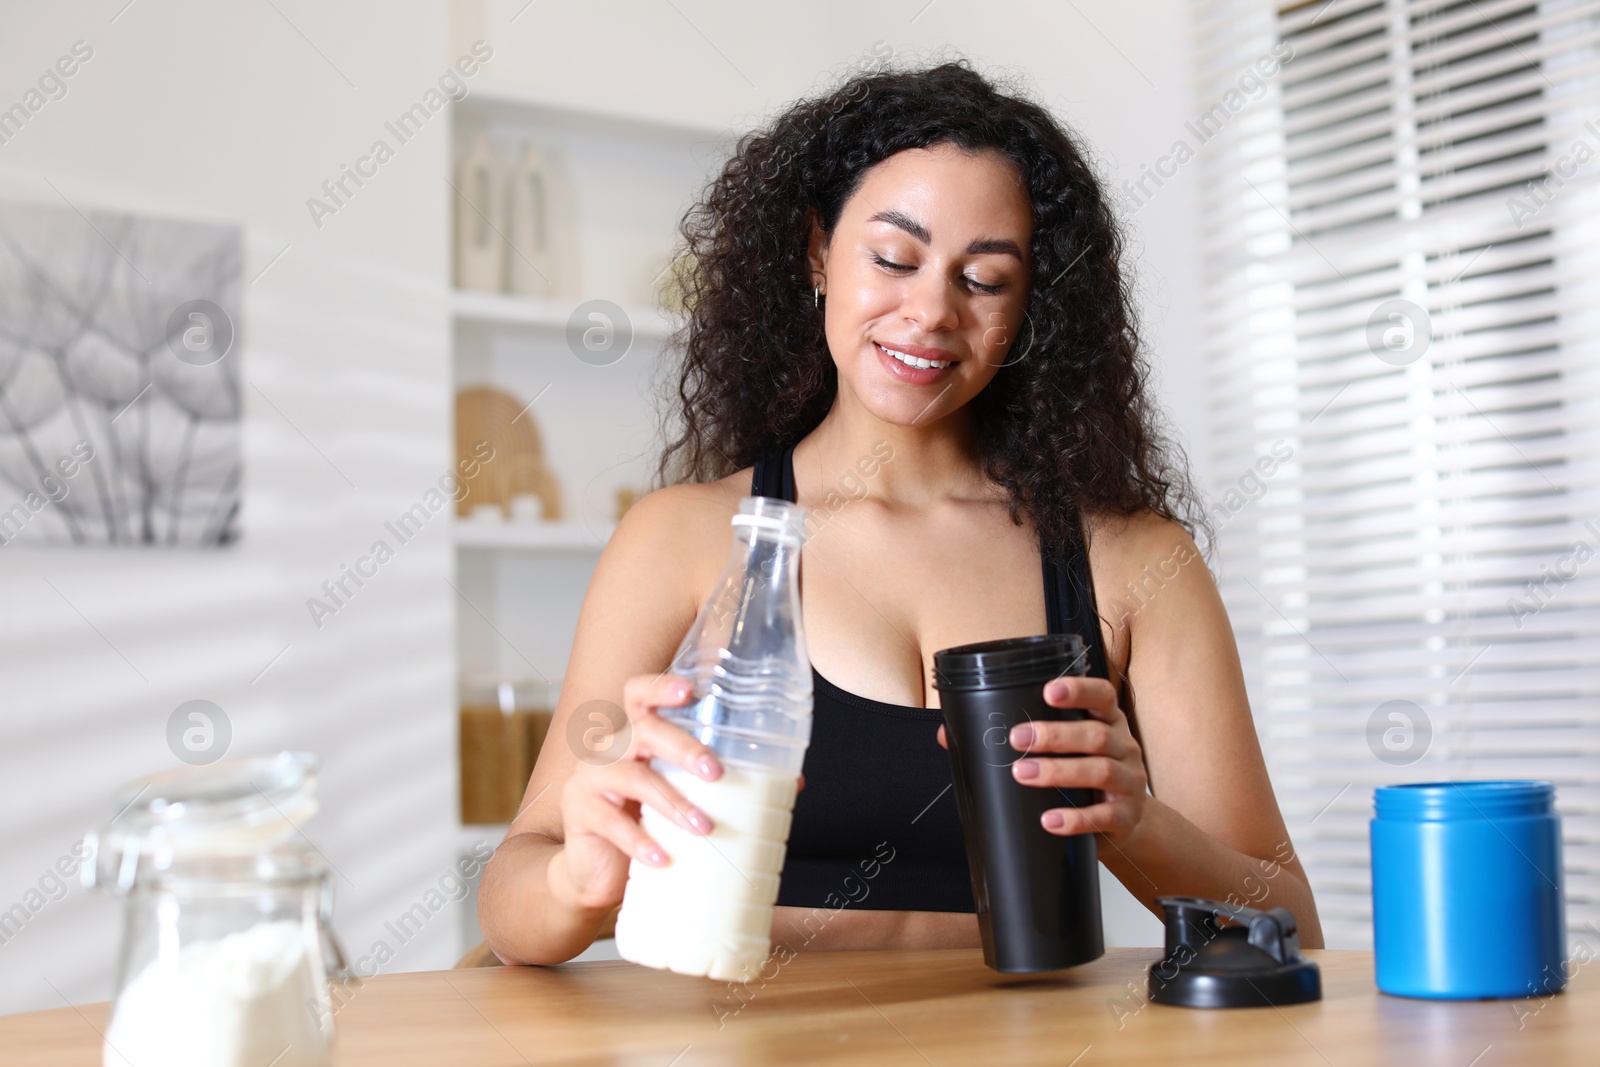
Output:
[{"xmin": 478, "ymin": 486, "xmax": 738, "ymax": 963}]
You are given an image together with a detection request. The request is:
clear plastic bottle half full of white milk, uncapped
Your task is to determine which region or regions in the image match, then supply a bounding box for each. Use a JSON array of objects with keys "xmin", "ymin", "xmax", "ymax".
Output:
[{"xmin": 616, "ymin": 496, "xmax": 811, "ymax": 981}]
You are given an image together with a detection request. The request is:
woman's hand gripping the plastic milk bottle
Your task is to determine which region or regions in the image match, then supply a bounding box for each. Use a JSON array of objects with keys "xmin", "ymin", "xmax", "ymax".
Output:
[{"xmin": 547, "ymin": 675, "xmax": 722, "ymax": 910}]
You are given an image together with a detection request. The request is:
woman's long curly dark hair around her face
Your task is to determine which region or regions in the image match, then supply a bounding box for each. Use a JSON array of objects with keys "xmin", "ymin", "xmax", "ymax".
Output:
[{"xmin": 659, "ymin": 61, "xmax": 1210, "ymax": 545}]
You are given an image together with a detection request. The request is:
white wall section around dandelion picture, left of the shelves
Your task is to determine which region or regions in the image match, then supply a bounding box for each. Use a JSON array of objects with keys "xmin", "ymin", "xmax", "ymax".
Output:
[{"xmin": 0, "ymin": 0, "xmax": 456, "ymax": 1011}]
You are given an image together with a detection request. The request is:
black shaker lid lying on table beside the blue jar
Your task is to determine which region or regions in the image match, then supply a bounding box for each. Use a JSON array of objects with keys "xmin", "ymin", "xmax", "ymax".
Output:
[{"xmin": 1149, "ymin": 896, "xmax": 1322, "ymax": 1008}]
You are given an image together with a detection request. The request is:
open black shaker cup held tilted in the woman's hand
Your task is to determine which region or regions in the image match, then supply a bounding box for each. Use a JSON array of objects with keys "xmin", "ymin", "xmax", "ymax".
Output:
[{"xmin": 933, "ymin": 633, "xmax": 1106, "ymax": 974}]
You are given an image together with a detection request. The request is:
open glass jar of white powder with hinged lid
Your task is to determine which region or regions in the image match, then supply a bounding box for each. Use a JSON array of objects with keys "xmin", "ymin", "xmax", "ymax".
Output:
[{"xmin": 83, "ymin": 752, "xmax": 344, "ymax": 1067}]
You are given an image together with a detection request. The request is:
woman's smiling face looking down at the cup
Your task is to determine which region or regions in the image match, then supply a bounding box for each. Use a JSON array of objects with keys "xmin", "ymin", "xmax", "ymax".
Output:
[{"xmin": 810, "ymin": 144, "xmax": 1034, "ymax": 426}]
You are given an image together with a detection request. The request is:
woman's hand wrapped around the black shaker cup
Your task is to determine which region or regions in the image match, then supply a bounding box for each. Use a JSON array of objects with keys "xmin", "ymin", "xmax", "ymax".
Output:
[{"xmin": 939, "ymin": 677, "xmax": 1149, "ymax": 838}]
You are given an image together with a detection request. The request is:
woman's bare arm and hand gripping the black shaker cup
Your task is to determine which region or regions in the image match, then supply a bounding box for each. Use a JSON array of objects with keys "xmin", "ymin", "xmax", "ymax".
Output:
[{"xmin": 1011, "ymin": 515, "xmax": 1323, "ymax": 949}]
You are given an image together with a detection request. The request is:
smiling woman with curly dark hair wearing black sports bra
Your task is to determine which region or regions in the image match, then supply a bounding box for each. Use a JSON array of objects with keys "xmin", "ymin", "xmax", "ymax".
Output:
[{"xmin": 478, "ymin": 64, "xmax": 1322, "ymax": 963}]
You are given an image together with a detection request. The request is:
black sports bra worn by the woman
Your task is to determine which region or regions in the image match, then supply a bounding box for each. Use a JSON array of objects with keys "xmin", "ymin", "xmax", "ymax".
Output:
[{"xmin": 750, "ymin": 448, "xmax": 1109, "ymax": 912}]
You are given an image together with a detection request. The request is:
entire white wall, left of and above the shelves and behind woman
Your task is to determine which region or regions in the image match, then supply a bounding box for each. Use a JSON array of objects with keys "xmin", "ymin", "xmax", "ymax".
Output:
[{"xmin": 0, "ymin": 0, "xmax": 1203, "ymax": 1011}]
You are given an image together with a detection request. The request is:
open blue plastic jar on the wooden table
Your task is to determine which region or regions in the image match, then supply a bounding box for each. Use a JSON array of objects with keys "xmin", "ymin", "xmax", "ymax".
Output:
[{"xmin": 1371, "ymin": 782, "xmax": 1566, "ymax": 1000}]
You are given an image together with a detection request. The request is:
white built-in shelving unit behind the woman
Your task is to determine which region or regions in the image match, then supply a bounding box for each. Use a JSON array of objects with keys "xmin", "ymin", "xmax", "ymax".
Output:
[{"xmin": 446, "ymin": 82, "xmax": 731, "ymax": 945}]
